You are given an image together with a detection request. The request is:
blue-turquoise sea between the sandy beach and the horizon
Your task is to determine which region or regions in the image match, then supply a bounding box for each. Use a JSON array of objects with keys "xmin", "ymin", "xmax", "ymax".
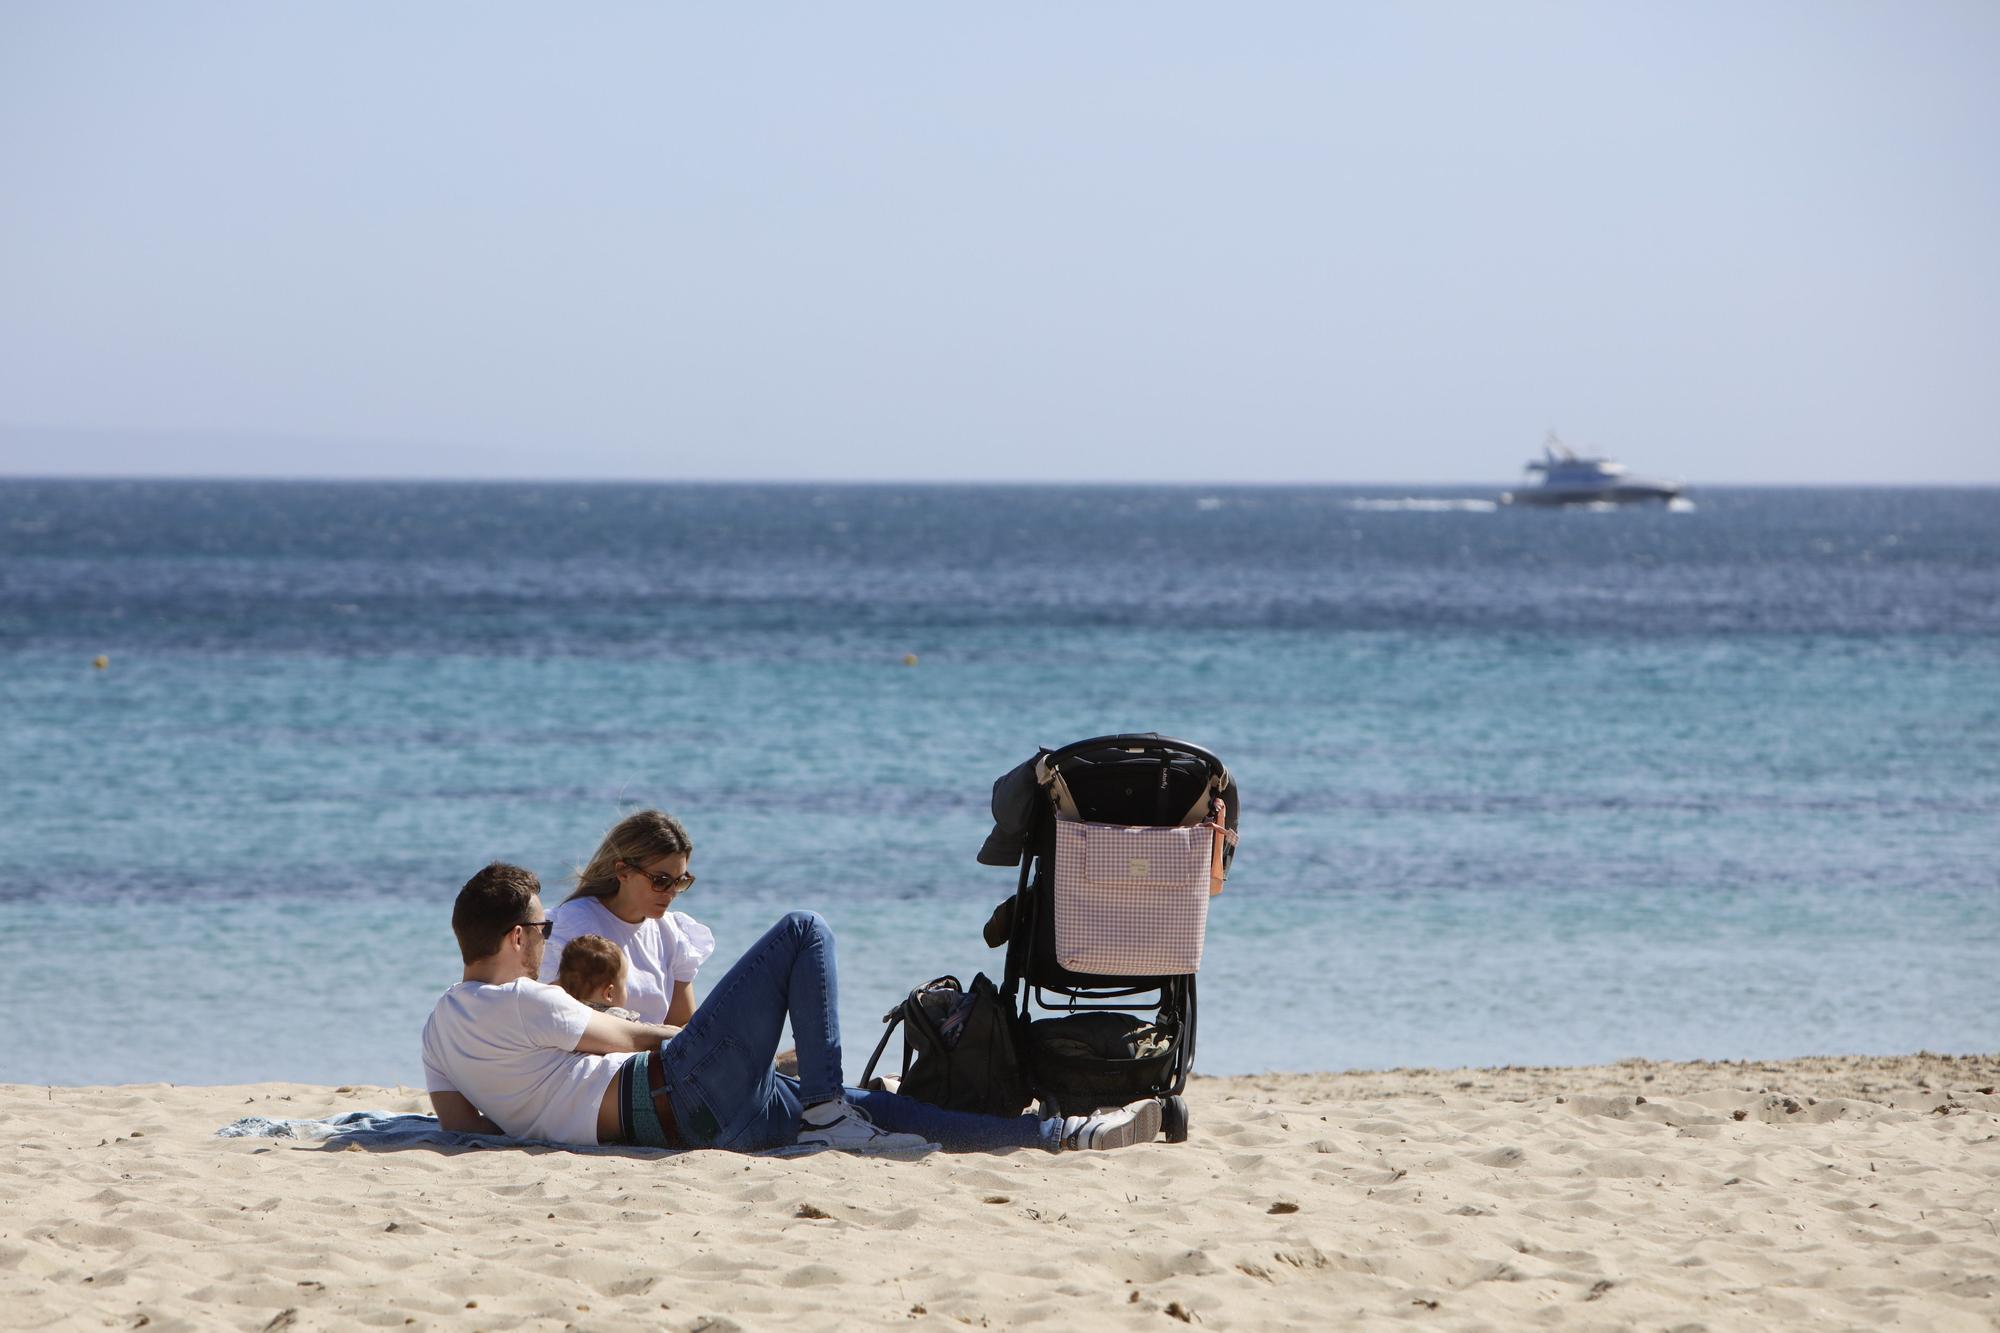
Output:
[{"xmin": 0, "ymin": 478, "xmax": 2000, "ymax": 1085}]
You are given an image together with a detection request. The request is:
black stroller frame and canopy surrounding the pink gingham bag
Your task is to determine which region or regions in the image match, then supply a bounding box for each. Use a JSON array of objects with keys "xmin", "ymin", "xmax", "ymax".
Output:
[{"xmin": 1000, "ymin": 733, "xmax": 1238, "ymax": 1143}]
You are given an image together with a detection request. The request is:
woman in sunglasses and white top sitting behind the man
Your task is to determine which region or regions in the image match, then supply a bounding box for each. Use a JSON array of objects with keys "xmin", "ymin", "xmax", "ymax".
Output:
[{"xmin": 538, "ymin": 811, "xmax": 716, "ymax": 1027}]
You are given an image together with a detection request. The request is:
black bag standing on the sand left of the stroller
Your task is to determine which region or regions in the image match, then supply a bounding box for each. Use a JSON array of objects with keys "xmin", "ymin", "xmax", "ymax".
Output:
[{"xmin": 862, "ymin": 973, "xmax": 1028, "ymax": 1115}]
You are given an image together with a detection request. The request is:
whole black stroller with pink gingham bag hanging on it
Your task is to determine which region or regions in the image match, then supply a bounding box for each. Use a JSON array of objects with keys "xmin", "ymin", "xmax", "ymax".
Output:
[{"xmin": 980, "ymin": 733, "xmax": 1238, "ymax": 1143}]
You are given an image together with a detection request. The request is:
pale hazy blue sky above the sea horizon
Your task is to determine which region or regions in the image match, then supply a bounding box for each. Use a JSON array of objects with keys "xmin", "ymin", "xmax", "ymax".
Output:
[{"xmin": 0, "ymin": 0, "xmax": 2000, "ymax": 482}]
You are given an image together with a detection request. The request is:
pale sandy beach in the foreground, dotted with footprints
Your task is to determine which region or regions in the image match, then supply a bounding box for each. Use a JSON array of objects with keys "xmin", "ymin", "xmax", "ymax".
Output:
[{"xmin": 0, "ymin": 1055, "xmax": 2000, "ymax": 1329}]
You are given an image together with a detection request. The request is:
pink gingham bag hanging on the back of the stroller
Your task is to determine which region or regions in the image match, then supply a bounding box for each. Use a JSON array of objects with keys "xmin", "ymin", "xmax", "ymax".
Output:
[{"xmin": 1054, "ymin": 819, "xmax": 1214, "ymax": 977}]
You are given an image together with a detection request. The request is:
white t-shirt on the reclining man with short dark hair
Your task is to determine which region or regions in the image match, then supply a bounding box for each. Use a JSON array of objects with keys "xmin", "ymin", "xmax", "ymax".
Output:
[{"xmin": 424, "ymin": 977, "xmax": 632, "ymax": 1143}]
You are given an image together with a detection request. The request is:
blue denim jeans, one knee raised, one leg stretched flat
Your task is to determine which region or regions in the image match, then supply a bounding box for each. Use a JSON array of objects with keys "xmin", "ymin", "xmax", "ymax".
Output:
[{"xmin": 660, "ymin": 913, "xmax": 1060, "ymax": 1153}]
